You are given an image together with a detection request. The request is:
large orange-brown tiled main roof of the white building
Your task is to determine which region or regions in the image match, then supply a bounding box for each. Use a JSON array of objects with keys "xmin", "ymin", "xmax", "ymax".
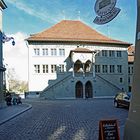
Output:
[{"xmin": 27, "ymin": 20, "xmax": 130, "ymax": 45}]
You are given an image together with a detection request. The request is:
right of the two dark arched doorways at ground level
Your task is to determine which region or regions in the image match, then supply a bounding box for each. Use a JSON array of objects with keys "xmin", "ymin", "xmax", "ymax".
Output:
[{"xmin": 85, "ymin": 81, "xmax": 93, "ymax": 98}]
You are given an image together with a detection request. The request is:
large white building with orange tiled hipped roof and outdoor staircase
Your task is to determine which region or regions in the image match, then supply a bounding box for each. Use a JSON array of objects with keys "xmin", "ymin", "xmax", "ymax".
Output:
[{"xmin": 27, "ymin": 20, "xmax": 131, "ymax": 99}]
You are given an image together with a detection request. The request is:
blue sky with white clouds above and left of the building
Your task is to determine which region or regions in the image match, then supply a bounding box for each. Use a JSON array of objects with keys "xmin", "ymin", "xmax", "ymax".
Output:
[{"xmin": 3, "ymin": 0, "xmax": 137, "ymax": 81}]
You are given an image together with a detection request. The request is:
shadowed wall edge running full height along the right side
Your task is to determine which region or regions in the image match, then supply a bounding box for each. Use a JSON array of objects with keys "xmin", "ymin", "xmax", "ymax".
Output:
[{"xmin": 124, "ymin": 0, "xmax": 140, "ymax": 140}]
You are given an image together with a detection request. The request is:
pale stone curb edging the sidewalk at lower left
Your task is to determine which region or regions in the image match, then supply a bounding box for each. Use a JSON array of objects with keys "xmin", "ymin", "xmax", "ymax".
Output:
[{"xmin": 0, "ymin": 103, "xmax": 32, "ymax": 125}]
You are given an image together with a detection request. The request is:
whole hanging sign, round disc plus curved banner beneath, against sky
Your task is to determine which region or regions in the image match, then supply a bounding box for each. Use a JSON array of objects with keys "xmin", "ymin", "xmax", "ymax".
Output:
[{"xmin": 93, "ymin": 0, "xmax": 121, "ymax": 25}]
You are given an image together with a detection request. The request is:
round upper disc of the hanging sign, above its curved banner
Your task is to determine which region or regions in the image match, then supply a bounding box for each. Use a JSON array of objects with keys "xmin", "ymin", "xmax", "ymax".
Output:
[{"xmin": 94, "ymin": 0, "xmax": 117, "ymax": 16}]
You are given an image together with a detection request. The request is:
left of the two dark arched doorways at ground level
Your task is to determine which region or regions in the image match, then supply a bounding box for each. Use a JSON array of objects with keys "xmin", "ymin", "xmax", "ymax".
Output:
[{"xmin": 75, "ymin": 81, "xmax": 83, "ymax": 98}]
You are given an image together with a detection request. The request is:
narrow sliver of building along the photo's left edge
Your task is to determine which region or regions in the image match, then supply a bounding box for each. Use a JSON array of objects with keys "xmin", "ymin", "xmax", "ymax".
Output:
[{"xmin": 0, "ymin": 0, "xmax": 7, "ymax": 108}]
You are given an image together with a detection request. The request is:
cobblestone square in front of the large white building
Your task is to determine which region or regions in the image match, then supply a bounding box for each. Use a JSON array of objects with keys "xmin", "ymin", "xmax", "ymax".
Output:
[{"xmin": 0, "ymin": 99, "xmax": 128, "ymax": 140}]
